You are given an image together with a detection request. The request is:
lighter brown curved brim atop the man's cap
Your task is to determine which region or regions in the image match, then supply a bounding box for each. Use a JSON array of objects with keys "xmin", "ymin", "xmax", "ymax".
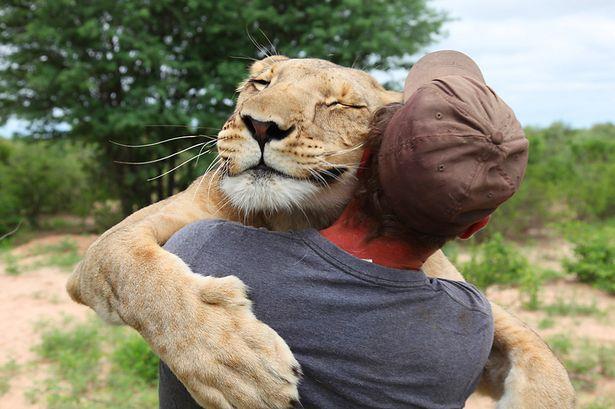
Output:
[{"xmin": 404, "ymin": 50, "xmax": 485, "ymax": 102}]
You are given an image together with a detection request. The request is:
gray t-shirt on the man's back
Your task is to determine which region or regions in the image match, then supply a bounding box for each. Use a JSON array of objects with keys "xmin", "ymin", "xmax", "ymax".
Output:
[{"xmin": 159, "ymin": 220, "xmax": 493, "ymax": 409}]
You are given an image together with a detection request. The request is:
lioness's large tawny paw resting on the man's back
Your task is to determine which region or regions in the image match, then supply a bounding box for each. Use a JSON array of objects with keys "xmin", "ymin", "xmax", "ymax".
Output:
[{"xmin": 162, "ymin": 276, "xmax": 301, "ymax": 409}]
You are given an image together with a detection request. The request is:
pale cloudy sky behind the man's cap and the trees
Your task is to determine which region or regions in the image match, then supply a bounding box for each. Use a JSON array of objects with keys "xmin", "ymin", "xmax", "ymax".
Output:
[{"xmin": 0, "ymin": 0, "xmax": 615, "ymax": 135}]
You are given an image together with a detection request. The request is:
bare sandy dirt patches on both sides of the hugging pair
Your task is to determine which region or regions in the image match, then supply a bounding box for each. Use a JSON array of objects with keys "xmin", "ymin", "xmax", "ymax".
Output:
[{"xmin": 0, "ymin": 235, "xmax": 615, "ymax": 409}]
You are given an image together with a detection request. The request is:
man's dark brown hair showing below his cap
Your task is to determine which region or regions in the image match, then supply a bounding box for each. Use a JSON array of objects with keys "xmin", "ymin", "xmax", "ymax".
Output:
[{"xmin": 355, "ymin": 103, "xmax": 454, "ymax": 251}]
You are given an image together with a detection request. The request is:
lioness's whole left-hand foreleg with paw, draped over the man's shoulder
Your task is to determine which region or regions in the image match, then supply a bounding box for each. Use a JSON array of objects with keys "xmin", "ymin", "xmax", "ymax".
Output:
[{"xmin": 67, "ymin": 174, "xmax": 300, "ymax": 409}]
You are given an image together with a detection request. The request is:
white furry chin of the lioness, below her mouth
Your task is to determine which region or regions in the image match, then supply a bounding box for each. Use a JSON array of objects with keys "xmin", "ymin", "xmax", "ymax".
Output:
[{"xmin": 220, "ymin": 172, "xmax": 322, "ymax": 214}]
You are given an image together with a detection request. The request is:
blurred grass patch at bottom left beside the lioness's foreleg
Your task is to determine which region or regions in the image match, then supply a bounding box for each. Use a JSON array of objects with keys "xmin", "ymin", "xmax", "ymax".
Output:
[{"xmin": 28, "ymin": 319, "xmax": 158, "ymax": 409}]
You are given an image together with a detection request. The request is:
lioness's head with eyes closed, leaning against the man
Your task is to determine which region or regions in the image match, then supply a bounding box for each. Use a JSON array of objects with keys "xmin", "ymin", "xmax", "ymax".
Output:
[{"xmin": 217, "ymin": 56, "xmax": 401, "ymax": 230}]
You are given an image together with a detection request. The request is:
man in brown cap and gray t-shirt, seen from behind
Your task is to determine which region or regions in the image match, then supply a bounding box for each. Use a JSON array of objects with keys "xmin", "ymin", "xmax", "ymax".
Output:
[{"xmin": 160, "ymin": 52, "xmax": 527, "ymax": 409}]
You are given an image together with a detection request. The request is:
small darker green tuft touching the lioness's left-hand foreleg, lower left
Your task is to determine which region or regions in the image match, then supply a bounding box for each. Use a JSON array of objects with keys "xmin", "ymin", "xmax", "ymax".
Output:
[{"xmin": 112, "ymin": 333, "xmax": 159, "ymax": 386}]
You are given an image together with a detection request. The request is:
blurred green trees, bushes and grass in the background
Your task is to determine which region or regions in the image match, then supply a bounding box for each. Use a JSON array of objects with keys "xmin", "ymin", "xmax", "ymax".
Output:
[{"xmin": 0, "ymin": 0, "xmax": 615, "ymax": 408}]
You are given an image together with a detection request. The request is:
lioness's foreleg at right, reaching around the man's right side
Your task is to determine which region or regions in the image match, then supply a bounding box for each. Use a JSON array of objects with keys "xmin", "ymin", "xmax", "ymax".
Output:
[{"xmin": 423, "ymin": 251, "xmax": 575, "ymax": 409}]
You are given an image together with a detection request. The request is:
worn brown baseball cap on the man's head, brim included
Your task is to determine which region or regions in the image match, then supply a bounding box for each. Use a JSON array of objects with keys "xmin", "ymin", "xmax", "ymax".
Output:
[{"xmin": 378, "ymin": 51, "xmax": 528, "ymax": 237}]
